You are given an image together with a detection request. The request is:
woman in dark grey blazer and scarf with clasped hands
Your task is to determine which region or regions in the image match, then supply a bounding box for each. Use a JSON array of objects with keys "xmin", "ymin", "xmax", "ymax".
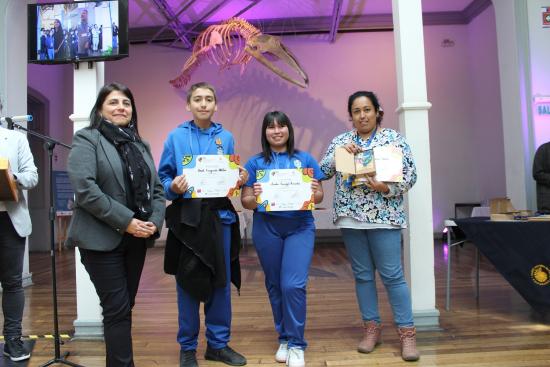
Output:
[{"xmin": 68, "ymin": 83, "xmax": 165, "ymax": 367}]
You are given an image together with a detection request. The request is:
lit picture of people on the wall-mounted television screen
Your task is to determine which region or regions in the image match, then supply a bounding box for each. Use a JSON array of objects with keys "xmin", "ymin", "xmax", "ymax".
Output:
[{"xmin": 36, "ymin": 1, "xmax": 119, "ymax": 61}]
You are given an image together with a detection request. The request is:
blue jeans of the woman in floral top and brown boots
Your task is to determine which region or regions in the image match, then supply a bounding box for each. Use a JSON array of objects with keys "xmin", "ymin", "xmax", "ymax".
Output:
[{"xmin": 342, "ymin": 228, "xmax": 414, "ymax": 327}]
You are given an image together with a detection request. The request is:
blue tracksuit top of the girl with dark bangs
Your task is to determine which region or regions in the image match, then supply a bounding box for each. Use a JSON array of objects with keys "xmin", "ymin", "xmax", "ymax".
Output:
[{"xmin": 244, "ymin": 150, "xmax": 325, "ymax": 218}]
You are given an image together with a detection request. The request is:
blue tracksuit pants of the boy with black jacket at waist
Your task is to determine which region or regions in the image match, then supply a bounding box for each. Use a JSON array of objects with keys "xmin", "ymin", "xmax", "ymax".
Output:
[{"xmin": 177, "ymin": 224, "xmax": 231, "ymax": 350}]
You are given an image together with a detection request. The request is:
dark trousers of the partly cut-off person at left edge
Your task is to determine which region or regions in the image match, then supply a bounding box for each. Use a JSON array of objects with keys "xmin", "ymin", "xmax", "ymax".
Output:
[{"xmin": 0, "ymin": 211, "xmax": 25, "ymax": 339}]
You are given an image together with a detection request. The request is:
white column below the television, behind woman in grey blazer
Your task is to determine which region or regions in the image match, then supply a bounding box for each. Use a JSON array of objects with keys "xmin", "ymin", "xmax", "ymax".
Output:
[{"xmin": 69, "ymin": 62, "xmax": 104, "ymax": 339}]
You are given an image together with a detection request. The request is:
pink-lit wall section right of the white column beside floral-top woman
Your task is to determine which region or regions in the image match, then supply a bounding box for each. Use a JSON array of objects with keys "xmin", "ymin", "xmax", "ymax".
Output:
[{"xmin": 424, "ymin": 26, "xmax": 479, "ymax": 226}]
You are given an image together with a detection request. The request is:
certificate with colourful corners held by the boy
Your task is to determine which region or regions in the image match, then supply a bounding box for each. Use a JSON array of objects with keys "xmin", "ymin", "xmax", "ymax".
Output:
[{"xmin": 182, "ymin": 155, "xmax": 240, "ymax": 198}]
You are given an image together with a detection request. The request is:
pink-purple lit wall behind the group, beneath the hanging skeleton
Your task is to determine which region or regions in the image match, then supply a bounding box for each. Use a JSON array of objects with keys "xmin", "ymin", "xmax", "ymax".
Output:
[{"xmin": 106, "ymin": 33, "xmax": 397, "ymax": 165}]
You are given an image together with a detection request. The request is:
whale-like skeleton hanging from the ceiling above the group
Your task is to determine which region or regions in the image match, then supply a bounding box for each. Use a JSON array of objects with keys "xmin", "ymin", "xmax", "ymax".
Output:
[{"xmin": 170, "ymin": 18, "xmax": 309, "ymax": 88}]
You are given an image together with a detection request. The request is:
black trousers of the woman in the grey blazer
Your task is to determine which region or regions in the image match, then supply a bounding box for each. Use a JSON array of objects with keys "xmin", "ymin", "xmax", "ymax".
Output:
[{"xmin": 80, "ymin": 234, "xmax": 147, "ymax": 367}]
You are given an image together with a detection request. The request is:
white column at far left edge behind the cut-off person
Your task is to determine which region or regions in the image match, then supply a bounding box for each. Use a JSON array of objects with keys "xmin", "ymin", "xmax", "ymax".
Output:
[{"xmin": 0, "ymin": 0, "xmax": 32, "ymax": 289}]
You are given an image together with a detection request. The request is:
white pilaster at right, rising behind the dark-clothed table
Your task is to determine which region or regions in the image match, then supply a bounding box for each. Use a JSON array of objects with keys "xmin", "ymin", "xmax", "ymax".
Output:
[{"xmin": 493, "ymin": 0, "xmax": 536, "ymax": 209}]
